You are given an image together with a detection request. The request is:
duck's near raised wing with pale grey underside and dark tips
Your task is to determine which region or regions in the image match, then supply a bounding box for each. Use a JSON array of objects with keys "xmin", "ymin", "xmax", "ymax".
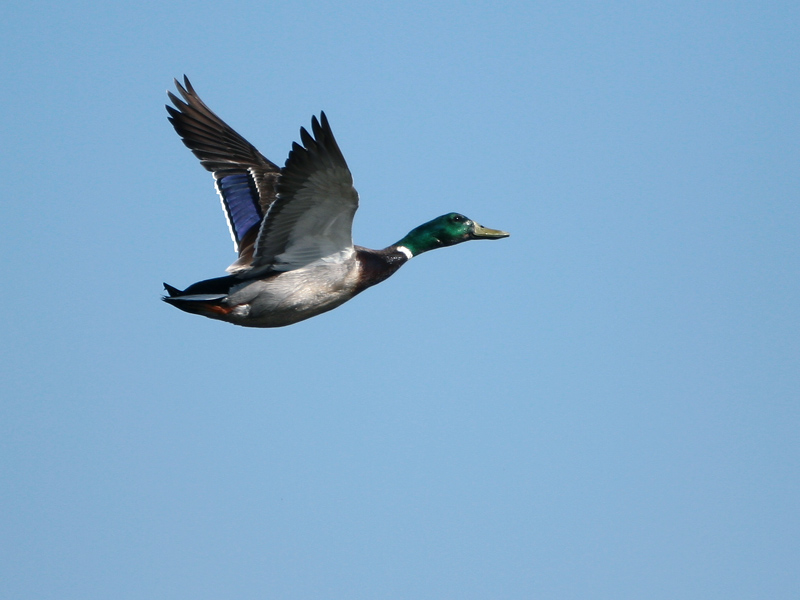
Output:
[{"xmin": 252, "ymin": 113, "xmax": 358, "ymax": 271}]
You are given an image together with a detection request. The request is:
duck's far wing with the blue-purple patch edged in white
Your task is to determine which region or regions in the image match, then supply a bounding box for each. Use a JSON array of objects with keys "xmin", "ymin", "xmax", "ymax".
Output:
[{"xmin": 167, "ymin": 76, "xmax": 281, "ymax": 271}]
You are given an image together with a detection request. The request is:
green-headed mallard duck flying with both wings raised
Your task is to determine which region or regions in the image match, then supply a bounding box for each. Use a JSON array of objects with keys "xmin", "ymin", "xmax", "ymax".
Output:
[{"xmin": 162, "ymin": 76, "xmax": 509, "ymax": 327}]
